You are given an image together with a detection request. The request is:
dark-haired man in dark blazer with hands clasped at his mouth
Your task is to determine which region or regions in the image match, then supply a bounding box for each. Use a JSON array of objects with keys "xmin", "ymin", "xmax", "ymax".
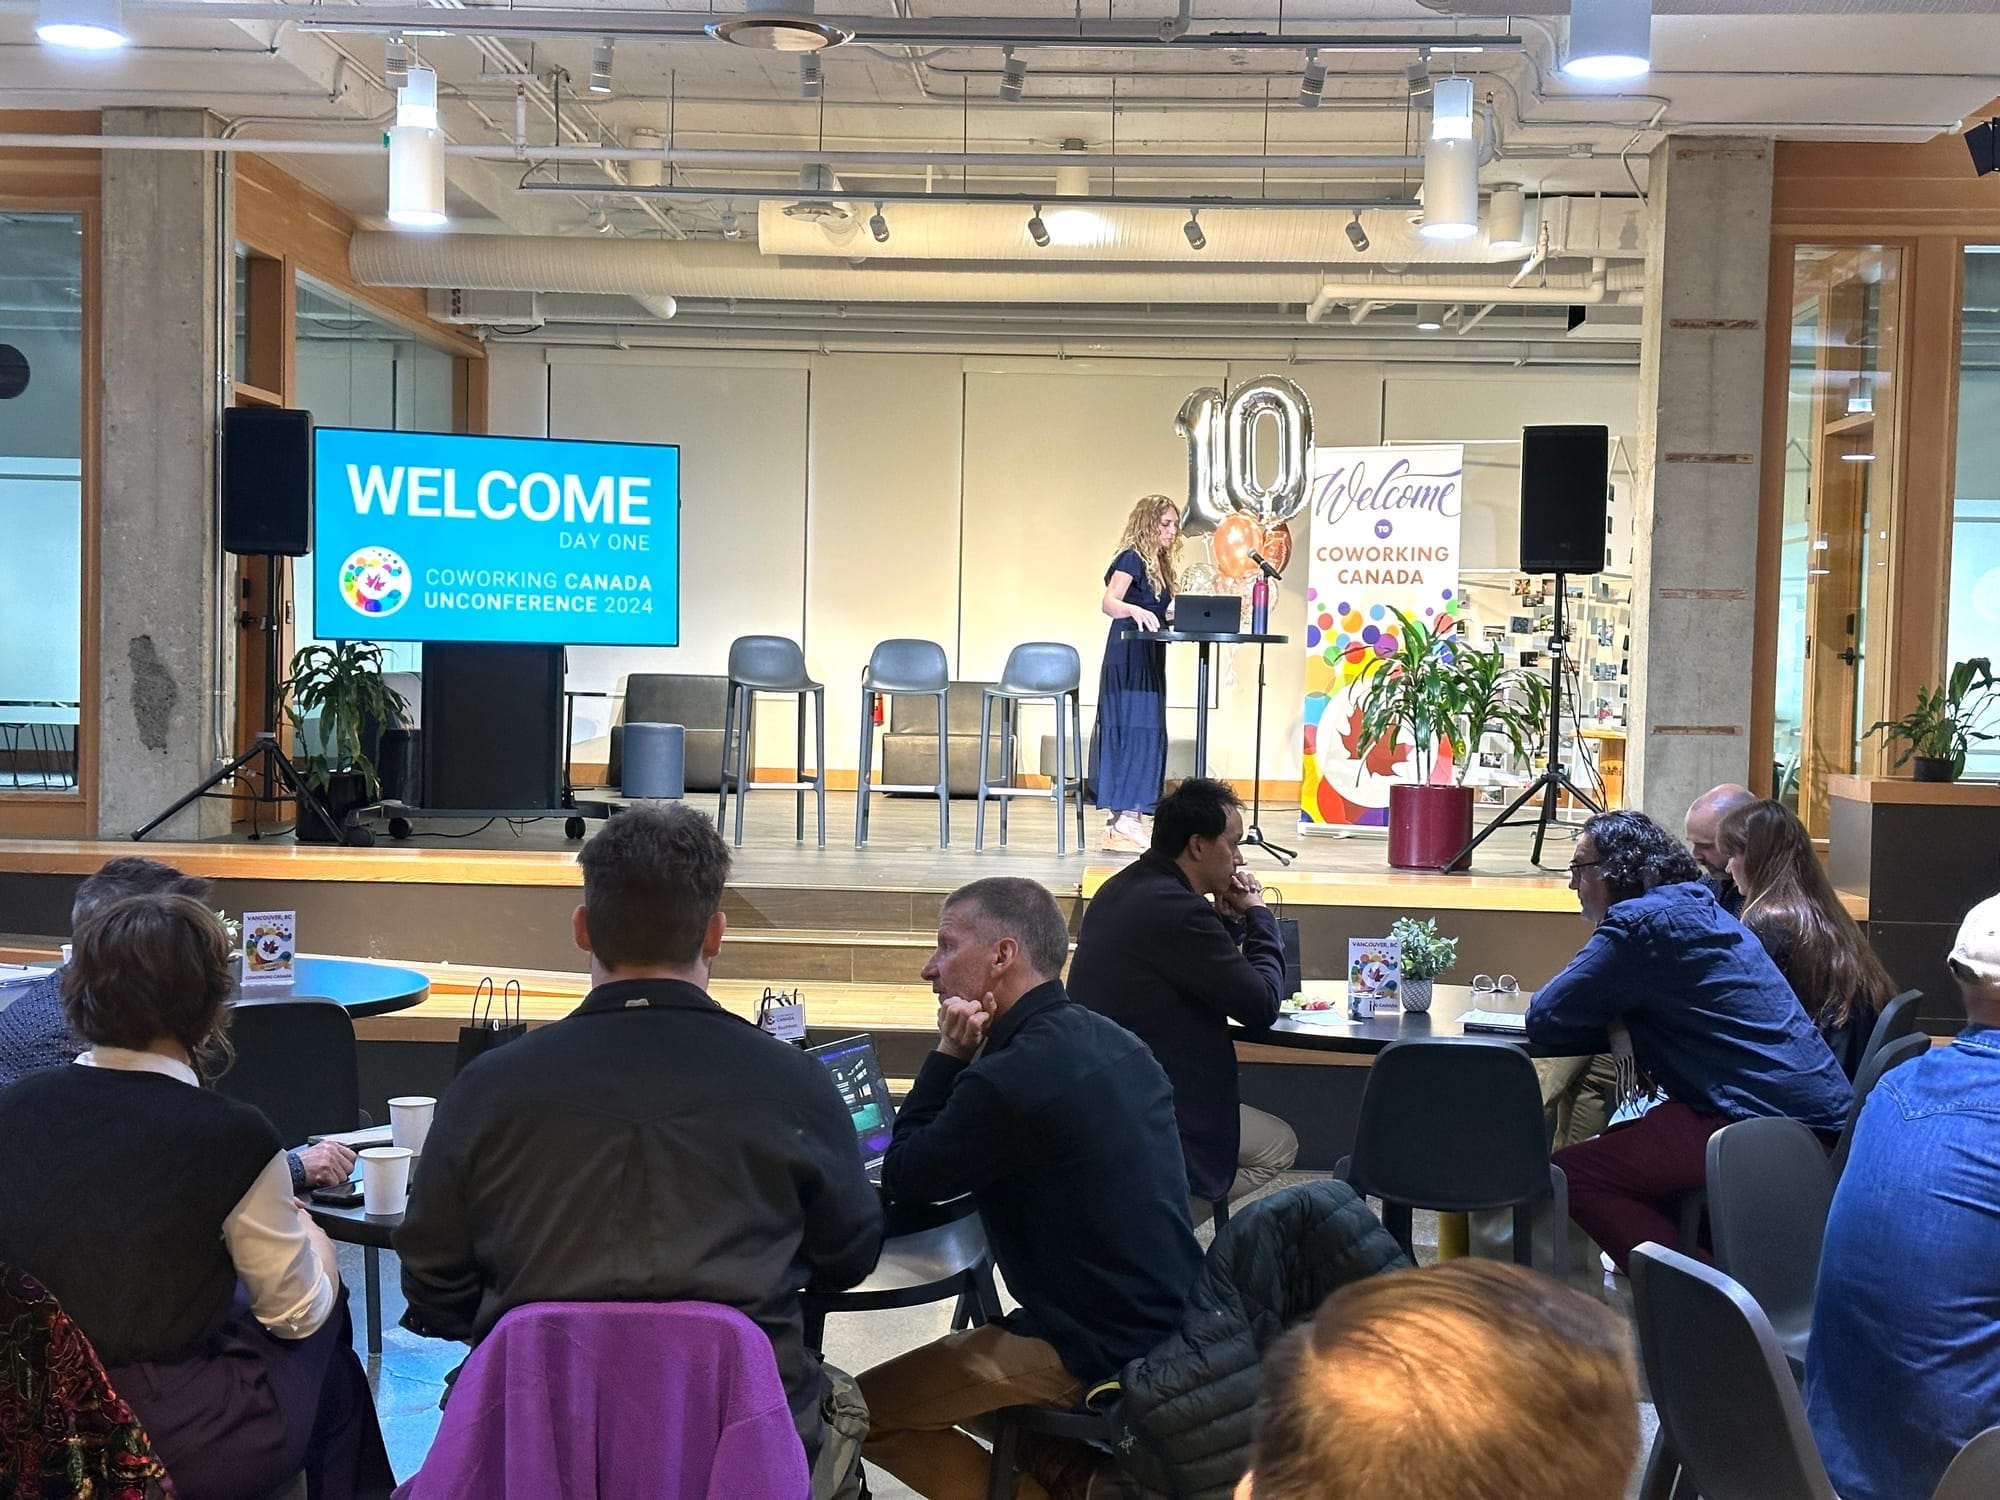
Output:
[{"xmin": 1070, "ymin": 778, "xmax": 1298, "ymax": 1214}]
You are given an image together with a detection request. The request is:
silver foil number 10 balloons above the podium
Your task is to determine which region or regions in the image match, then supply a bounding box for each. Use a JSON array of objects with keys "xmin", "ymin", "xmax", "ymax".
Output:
[{"xmin": 1174, "ymin": 376, "xmax": 1312, "ymax": 536}]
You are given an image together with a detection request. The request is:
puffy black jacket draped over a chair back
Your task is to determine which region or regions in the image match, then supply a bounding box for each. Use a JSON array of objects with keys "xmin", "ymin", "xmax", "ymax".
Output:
[{"xmin": 1116, "ymin": 1182, "xmax": 1410, "ymax": 1500}]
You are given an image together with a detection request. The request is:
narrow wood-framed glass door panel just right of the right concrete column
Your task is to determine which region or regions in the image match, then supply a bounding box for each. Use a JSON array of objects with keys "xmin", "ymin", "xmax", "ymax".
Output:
[{"xmin": 1772, "ymin": 244, "xmax": 1902, "ymax": 838}]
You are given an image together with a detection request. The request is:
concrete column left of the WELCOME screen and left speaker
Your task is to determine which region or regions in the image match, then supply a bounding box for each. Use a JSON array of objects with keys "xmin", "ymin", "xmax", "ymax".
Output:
[{"xmin": 98, "ymin": 110, "xmax": 232, "ymax": 838}]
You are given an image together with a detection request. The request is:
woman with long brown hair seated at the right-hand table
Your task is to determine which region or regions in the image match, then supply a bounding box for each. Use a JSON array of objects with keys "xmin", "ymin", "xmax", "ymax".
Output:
[{"xmin": 1716, "ymin": 802, "xmax": 1896, "ymax": 1078}]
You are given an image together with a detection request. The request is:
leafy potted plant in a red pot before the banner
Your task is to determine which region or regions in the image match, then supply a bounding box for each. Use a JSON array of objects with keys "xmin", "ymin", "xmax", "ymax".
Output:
[{"xmin": 1360, "ymin": 610, "xmax": 1548, "ymax": 870}]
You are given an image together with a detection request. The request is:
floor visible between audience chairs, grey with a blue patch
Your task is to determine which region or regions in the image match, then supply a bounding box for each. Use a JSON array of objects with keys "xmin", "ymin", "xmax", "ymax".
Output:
[{"xmin": 340, "ymin": 1172, "xmax": 1654, "ymax": 1500}]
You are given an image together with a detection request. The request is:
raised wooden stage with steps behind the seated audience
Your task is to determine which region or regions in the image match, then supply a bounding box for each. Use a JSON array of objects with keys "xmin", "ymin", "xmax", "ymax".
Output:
[{"xmin": 0, "ymin": 792, "xmax": 1586, "ymax": 1164}]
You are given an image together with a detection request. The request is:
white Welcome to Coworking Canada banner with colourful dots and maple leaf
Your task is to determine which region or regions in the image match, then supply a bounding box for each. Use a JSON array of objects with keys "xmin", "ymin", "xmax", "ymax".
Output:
[{"xmin": 1300, "ymin": 444, "xmax": 1466, "ymax": 826}]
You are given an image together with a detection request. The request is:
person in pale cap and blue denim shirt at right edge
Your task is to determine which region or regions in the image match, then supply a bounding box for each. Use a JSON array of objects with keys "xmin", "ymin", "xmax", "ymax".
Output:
[{"xmin": 1806, "ymin": 896, "xmax": 2000, "ymax": 1500}]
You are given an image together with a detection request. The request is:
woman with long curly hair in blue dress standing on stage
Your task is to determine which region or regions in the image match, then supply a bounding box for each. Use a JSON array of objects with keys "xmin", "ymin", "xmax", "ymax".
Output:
[{"xmin": 1090, "ymin": 494, "xmax": 1180, "ymax": 850}]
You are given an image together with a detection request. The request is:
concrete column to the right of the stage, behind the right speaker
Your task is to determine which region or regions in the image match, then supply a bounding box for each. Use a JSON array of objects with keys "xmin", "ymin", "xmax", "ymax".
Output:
[{"xmin": 1626, "ymin": 136, "xmax": 1772, "ymax": 832}]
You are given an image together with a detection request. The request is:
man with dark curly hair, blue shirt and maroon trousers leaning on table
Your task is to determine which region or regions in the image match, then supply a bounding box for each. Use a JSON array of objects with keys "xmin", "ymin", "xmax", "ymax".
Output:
[{"xmin": 1528, "ymin": 812, "xmax": 1852, "ymax": 1270}]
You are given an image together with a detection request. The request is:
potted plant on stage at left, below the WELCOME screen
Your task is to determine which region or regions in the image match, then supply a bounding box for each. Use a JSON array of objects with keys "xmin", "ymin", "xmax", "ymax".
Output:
[{"xmin": 278, "ymin": 640, "xmax": 406, "ymax": 844}]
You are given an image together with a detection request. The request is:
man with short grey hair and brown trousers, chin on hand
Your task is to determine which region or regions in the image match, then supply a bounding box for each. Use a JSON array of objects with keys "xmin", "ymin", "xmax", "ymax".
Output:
[{"xmin": 860, "ymin": 878, "xmax": 1202, "ymax": 1498}]
